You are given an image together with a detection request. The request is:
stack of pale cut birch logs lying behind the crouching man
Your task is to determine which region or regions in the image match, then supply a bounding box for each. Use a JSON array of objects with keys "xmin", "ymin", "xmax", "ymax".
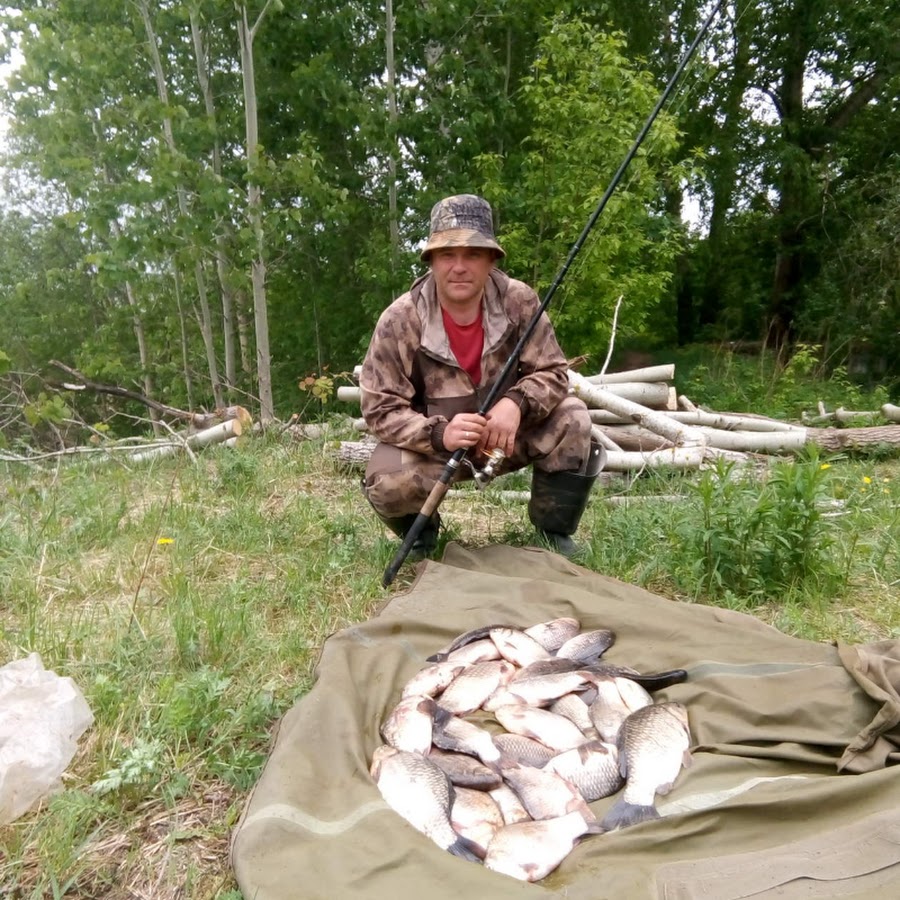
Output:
[{"xmin": 337, "ymin": 365, "xmax": 900, "ymax": 472}]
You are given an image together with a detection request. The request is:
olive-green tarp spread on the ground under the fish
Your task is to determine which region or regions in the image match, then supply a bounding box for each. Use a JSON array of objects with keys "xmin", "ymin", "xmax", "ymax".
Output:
[{"xmin": 232, "ymin": 544, "xmax": 900, "ymax": 900}]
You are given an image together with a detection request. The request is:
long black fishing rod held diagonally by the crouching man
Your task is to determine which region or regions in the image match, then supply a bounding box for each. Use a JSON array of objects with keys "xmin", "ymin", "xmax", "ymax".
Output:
[{"xmin": 381, "ymin": 0, "xmax": 725, "ymax": 587}]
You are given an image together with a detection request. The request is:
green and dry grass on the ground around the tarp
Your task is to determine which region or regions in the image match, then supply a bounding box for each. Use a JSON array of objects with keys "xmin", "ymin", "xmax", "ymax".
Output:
[{"xmin": 0, "ymin": 390, "xmax": 900, "ymax": 900}]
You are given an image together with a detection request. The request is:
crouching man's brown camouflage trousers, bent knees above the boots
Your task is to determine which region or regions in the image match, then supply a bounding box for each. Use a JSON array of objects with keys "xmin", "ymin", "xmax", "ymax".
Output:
[{"xmin": 363, "ymin": 397, "xmax": 591, "ymax": 519}]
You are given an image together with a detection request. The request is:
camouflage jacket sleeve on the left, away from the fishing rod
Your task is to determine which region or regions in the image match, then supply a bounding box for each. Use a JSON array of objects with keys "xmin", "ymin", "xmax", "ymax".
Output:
[{"xmin": 359, "ymin": 294, "xmax": 447, "ymax": 454}]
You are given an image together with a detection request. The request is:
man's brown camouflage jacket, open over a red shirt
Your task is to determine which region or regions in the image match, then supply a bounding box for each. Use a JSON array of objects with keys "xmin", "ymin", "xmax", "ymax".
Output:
[{"xmin": 360, "ymin": 269, "xmax": 568, "ymax": 454}]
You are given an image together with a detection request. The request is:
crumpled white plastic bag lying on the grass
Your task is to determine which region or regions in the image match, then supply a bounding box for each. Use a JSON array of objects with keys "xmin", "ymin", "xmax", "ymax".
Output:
[{"xmin": 0, "ymin": 653, "xmax": 94, "ymax": 825}]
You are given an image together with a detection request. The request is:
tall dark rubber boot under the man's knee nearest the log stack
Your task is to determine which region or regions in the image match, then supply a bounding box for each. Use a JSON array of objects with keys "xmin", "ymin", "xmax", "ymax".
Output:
[{"xmin": 528, "ymin": 441, "xmax": 606, "ymax": 557}]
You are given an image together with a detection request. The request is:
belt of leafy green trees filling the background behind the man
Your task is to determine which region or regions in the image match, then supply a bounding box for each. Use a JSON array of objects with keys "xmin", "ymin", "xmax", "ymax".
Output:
[{"xmin": 0, "ymin": 0, "xmax": 900, "ymax": 430}]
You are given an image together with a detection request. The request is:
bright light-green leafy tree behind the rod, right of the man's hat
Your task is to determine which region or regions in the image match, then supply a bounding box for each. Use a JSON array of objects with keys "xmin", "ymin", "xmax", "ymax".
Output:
[{"xmin": 479, "ymin": 17, "xmax": 680, "ymax": 357}]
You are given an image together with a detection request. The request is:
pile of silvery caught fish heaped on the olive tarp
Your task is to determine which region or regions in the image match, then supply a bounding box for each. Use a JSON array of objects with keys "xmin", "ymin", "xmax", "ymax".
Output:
[{"xmin": 370, "ymin": 617, "xmax": 691, "ymax": 881}]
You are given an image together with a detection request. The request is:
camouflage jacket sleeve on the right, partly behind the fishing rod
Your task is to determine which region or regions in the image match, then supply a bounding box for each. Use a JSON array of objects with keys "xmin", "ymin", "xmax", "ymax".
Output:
[{"xmin": 505, "ymin": 281, "xmax": 569, "ymax": 423}]
